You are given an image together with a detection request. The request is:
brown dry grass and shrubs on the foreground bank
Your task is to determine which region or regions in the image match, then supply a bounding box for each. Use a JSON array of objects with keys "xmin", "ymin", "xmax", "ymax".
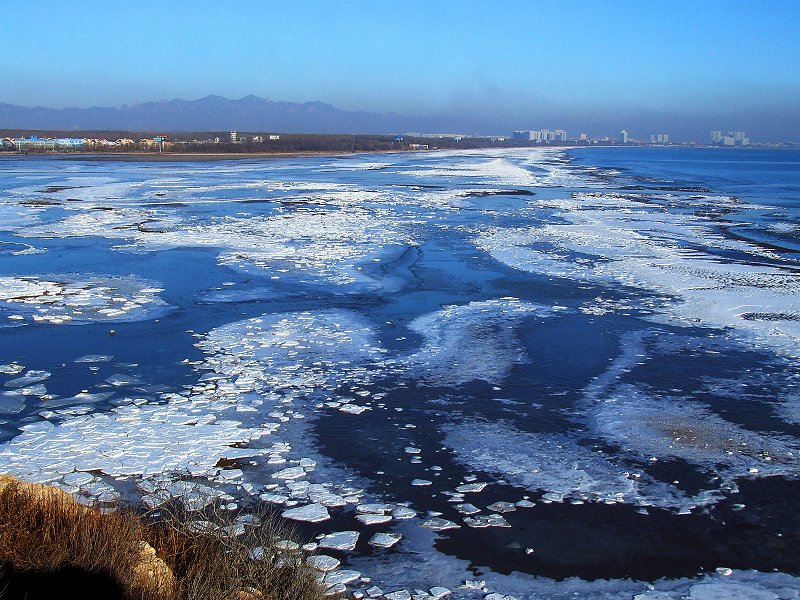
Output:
[{"xmin": 0, "ymin": 480, "xmax": 323, "ymax": 600}]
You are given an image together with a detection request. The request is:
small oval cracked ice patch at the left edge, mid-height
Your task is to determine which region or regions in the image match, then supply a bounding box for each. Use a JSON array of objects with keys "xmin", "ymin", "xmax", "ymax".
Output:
[{"xmin": 0, "ymin": 274, "xmax": 172, "ymax": 324}]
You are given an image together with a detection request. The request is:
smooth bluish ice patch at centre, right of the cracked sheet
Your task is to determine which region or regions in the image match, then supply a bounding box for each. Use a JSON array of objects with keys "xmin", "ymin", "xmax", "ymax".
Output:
[{"xmin": 404, "ymin": 298, "xmax": 552, "ymax": 385}]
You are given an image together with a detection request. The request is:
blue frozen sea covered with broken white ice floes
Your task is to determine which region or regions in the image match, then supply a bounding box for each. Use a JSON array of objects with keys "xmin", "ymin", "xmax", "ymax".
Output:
[{"xmin": 0, "ymin": 148, "xmax": 800, "ymax": 600}]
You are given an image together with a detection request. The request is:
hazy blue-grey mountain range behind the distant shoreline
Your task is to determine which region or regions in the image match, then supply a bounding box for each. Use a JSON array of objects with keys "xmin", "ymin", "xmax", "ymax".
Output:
[{"xmin": 0, "ymin": 95, "xmax": 456, "ymax": 134}]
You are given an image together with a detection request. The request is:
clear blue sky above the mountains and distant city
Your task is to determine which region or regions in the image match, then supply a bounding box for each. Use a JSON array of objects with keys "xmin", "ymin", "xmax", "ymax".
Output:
[{"xmin": 0, "ymin": 0, "xmax": 800, "ymax": 138}]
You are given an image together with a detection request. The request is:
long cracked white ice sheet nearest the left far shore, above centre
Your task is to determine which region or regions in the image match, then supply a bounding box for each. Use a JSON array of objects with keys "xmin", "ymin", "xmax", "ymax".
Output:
[{"xmin": 21, "ymin": 199, "xmax": 415, "ymax": 286}]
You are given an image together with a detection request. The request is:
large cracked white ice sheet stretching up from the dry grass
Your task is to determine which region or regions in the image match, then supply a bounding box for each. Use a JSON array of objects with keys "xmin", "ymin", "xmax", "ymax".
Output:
[{"xmin": 0, "ymin": 310, "xmax": 390, "ymax": 488}]
